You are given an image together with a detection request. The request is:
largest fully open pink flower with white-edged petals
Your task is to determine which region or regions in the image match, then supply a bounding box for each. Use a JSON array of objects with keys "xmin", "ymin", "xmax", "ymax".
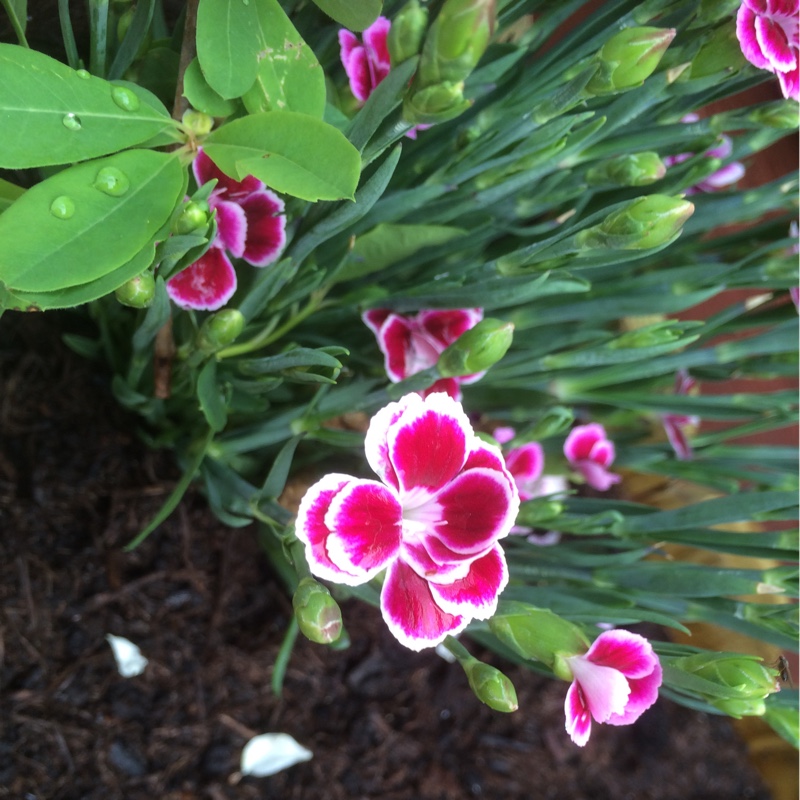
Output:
[{"xmin": 295, "ymin": 393, "xmax": 519, "ymax": 650}]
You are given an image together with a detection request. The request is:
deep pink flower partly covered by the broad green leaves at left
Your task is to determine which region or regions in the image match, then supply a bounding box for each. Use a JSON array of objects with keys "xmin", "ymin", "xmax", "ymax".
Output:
[{"xmin": 167, "ymin": 150, "xmax": 286, "ymax": 311}]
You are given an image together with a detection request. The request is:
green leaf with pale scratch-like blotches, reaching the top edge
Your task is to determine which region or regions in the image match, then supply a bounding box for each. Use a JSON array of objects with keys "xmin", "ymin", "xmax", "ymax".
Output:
[{"xmin": 242, "ymin": 0, "xmax": 325, "ymax": 119}]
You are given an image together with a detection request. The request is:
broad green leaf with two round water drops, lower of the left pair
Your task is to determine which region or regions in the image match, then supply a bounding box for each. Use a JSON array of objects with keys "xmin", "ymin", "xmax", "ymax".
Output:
[{"xmin": 0, "ymin": 150, "xmax": 187, "ymax": 292}]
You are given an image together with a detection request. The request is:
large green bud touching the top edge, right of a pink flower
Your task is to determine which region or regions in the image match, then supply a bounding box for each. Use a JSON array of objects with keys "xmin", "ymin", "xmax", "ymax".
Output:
[{"xmin": 416, "ymin": 0, "xmax": 495, "ymax": 87}]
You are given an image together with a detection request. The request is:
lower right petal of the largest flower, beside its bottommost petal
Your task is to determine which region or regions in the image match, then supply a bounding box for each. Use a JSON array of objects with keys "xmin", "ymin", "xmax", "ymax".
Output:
[{"xmin": 430, "ymin": 545, "xmax": 508, "ymax": 619}]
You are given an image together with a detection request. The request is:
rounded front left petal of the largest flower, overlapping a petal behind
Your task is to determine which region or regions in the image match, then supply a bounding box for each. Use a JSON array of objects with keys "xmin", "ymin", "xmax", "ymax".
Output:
[{"xmin": 324, "ymin": 480, "xmax": 403, "ymax": 583}]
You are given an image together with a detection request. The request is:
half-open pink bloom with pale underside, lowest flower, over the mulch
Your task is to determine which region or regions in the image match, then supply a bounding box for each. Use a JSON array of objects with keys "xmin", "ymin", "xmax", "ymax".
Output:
[{"xmin": 564, "ymin": 630, "xmax": 661, "ymax": 747}]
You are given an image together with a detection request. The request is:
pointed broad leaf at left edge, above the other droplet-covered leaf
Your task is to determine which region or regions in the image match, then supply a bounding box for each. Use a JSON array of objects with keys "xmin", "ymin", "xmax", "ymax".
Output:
[{"xmin": 0, "ymin": 44, "xmax": 174, "ymax": 169}]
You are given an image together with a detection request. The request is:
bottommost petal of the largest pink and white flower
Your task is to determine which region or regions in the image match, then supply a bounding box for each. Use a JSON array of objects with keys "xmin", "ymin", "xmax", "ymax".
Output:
[{"xmin": 381, "ymin": 559, "xmax": 469, "ymax": 651}]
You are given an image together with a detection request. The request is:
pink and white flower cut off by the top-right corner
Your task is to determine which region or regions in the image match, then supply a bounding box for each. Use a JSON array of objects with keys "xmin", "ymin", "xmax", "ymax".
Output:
[{"xmin": 736, "ymin": 0, "xmax": 800, "ymax": 100}]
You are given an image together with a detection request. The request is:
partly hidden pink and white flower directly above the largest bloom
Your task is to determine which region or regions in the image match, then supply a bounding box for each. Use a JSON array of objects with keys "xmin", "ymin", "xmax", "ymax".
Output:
[{"xmin": 362, "ymin": 308, "xmax": 485, "ymax": 400}]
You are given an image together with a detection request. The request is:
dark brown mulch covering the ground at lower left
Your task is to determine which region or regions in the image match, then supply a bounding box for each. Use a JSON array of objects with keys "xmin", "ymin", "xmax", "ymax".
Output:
[{"xmin": 0, "ymin": 314, "xmax": 769, "ymax": 800}]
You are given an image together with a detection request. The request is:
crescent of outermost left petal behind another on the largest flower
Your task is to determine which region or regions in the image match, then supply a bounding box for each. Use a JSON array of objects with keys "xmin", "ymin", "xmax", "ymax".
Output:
[{"xmin": 295, "ymin": 473, "xmax": 363, "ymax": 586}]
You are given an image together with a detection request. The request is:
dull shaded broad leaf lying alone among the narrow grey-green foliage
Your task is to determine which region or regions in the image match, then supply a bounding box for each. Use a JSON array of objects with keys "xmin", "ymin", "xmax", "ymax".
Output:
[{"xmin": 338, "ymin": 223, "xmax": 466, "ymax": 280}]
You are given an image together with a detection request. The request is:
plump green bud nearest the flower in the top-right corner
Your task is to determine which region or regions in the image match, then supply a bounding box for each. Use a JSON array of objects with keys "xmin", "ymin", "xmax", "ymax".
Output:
[{"xmin": 586, "ymin": 28, "xmax": 675, "ymax": 95}]
